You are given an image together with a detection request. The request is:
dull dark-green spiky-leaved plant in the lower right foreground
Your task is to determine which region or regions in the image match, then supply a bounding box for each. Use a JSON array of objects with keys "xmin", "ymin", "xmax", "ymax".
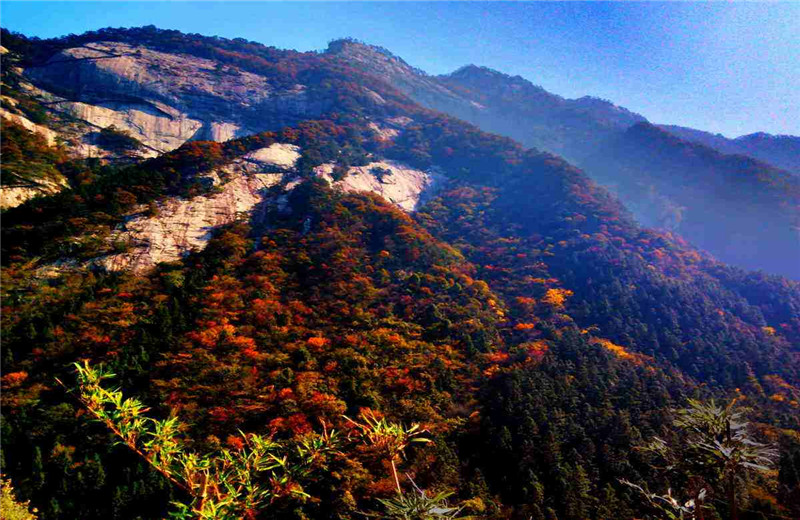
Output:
[{"xmin": 622, "ymin": 399, "xmax": 777, "ymax": 520}]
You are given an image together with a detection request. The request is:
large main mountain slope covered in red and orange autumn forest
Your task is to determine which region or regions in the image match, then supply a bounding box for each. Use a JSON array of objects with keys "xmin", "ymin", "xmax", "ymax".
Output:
[{"xmin": 0, "ymin": 29, "xmax": 800, "ymax": 520}]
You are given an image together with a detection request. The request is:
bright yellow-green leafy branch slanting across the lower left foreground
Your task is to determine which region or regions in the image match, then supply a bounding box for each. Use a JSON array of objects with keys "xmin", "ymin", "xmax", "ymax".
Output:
[{"xmin": 65, "ymin": 362, "xmax": 343, "ymax": 519}]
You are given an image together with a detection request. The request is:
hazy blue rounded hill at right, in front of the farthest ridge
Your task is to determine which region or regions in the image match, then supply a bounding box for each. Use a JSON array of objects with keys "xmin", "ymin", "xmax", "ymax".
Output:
[{"xmin": 586, "ymin": 123, "xmax": 800, "ymax": 279}]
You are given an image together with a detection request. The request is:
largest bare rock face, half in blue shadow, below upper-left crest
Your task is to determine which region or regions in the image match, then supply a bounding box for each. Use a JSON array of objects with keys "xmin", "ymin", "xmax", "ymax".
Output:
[{"xmin": 25, "ymin": 42, "xmax": 330, "ymax": 155}]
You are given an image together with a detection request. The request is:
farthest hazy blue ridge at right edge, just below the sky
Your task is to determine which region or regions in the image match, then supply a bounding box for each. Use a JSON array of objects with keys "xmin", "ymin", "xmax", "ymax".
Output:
[{"xmin": 659, "ymin": 125, "xmax": 800, "ymax": 175}]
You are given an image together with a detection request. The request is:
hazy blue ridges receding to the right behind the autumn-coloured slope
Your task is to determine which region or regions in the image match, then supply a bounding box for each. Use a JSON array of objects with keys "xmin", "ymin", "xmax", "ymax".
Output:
[{"xmin": 328, "ymin": 41, "xmax": 800, "ymax": 279}]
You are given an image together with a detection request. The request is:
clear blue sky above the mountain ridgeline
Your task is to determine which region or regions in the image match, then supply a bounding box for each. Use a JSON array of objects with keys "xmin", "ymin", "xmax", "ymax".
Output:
[{"xmin": 0, "ymin": 0, "xmax": 800, "ymax": 137}]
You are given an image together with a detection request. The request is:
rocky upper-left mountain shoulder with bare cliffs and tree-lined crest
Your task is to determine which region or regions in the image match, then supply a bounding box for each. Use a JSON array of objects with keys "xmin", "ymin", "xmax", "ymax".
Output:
[{"xmin": 0, "ymin": 27, "xmax": 412, "ymax": 207}]
